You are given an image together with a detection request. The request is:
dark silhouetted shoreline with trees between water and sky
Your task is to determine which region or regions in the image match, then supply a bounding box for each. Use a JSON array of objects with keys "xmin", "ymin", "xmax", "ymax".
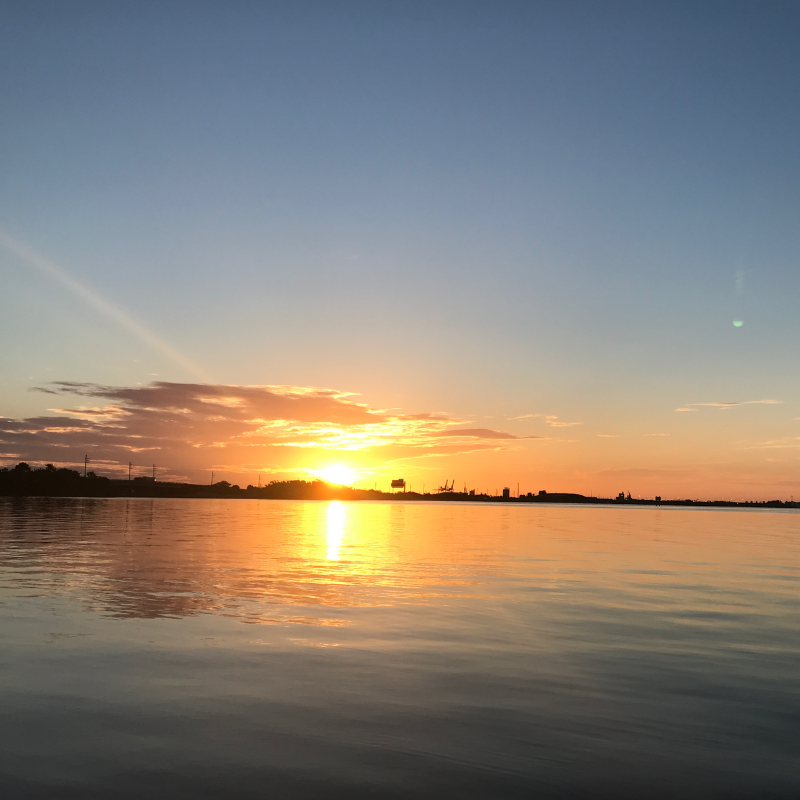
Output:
[{"xmin": 0, "ymin": 464, "xmax": 800, "ymax": 508}]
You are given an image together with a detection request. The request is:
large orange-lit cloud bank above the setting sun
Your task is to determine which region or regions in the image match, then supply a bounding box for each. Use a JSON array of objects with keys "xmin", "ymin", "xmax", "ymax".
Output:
[{"xmin": 0, "ymin": 381, "xmax": 541, "ymax": 479}]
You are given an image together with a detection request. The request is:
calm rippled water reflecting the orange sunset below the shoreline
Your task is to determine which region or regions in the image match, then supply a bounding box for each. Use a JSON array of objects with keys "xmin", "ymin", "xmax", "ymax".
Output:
[{"xmin": 0, "ymin": 499, "xmax": 800, "ymax": 798}]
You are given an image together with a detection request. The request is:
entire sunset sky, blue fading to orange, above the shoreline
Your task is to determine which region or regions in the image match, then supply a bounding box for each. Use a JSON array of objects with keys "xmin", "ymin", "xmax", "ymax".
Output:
[{"xmin": 0, "ymin": 0, "xmax": 800, "ymax": 499}]
